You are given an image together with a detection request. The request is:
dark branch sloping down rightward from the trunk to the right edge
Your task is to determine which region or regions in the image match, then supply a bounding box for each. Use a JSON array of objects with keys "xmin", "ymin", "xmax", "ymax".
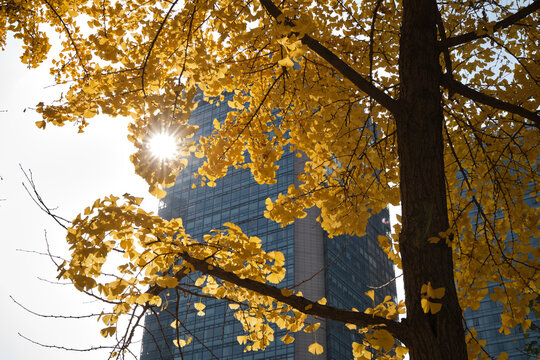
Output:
[{"xmin": 441, "ymin": 74, "xmax": 540, "ymax": 128}]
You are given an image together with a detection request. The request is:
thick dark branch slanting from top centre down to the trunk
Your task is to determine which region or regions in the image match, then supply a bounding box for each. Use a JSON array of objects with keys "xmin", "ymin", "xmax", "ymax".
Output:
[{"xmin": 259, "ymin": 0, "xmax": 400, "ymax": 114}]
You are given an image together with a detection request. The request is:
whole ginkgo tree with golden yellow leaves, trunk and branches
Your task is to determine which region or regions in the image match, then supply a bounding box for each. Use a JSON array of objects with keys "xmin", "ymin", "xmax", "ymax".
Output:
[{"xmin": 0, "ymin": 0, "xmax": 540, "ymax": 360}]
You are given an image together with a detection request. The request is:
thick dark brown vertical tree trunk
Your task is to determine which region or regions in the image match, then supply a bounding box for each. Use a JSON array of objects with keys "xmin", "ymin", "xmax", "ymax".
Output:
[{"xmin": 396, "ymin": 0, "xmax": 467, "ymax": 360}]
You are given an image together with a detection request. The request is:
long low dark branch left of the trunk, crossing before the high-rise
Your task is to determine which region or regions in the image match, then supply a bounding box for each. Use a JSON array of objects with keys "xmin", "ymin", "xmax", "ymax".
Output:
[{"xmin": 179, "ymin": 252, "xmax": 409, "ymax": 344}]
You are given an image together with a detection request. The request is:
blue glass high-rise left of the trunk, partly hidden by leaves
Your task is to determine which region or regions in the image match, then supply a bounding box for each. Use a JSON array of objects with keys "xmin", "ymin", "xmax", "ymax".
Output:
[{"xmin": 141, "ymin": 93, "xmax": 396, "ymax": 360}]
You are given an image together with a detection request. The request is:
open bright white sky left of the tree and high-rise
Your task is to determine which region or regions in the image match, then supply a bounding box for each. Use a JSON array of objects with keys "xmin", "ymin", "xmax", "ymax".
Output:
[{"xmin": 0, "ymin": 35, "xmax": 157, "ymax": 360}]
